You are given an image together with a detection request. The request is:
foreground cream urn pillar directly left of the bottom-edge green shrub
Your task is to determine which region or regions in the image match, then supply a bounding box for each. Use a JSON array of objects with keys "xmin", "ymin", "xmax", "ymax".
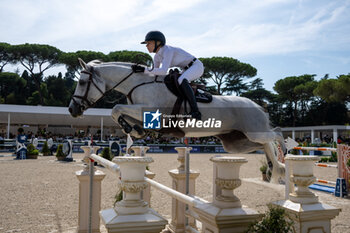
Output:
[{"xmin": 194, "ymin": 156, "xmax": 262, "ymax": 233}]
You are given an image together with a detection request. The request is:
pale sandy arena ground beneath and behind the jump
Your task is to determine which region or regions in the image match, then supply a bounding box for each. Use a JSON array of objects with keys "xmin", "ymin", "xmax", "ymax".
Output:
[{"xmin": 0, "ymin": 154, "xmax": 350, "ymax": 233}]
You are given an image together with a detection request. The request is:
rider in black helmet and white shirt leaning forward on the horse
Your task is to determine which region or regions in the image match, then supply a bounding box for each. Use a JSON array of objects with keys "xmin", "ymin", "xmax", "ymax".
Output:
[{"xmin": 132, "ymin": 31, "xmax": 204, "ymax": 120}]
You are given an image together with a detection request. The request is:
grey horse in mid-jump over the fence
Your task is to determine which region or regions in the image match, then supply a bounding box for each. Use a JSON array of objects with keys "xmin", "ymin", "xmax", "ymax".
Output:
[{"xmin": 69, "ymin": 59, "xmax": 285, "ymax": 183}]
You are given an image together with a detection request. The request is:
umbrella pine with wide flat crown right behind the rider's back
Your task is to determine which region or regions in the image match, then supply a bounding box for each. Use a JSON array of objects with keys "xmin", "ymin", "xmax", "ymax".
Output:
[{"xmin": 200, "ymin": 57, "xmax": 257, "ymax": 95}]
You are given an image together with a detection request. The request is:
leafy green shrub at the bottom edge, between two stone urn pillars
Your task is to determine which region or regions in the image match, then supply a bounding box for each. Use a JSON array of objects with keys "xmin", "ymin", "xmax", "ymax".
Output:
[{"xmin": 246, "ymin": 205, "xmax": 293, "ymax": 233}]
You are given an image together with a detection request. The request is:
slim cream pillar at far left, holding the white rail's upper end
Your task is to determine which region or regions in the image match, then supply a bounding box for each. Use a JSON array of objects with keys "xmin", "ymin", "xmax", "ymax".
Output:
[{"xmin": 75, "ymin": 146, "xmax": 106, "ymax": 233}]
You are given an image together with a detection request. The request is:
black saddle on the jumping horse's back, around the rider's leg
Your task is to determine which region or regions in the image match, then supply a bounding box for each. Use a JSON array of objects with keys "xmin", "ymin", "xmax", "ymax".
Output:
[{"xmin": 164, "ymin": 69, "xmax": 213, "ymax": 103}]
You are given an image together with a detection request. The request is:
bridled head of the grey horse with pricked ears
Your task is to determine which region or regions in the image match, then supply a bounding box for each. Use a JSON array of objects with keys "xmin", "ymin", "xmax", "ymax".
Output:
[{"xmin": 68, "ymin": 58, "xmax": 106, "ymax": 117}]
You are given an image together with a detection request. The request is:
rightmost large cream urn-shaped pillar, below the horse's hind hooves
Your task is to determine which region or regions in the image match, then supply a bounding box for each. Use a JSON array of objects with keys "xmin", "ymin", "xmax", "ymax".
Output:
[{"xmin": 273, "ymin": 155, "xmax": 341, "ymax": 233}]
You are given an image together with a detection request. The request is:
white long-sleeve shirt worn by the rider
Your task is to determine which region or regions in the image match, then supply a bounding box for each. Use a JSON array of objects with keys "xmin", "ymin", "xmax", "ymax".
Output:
[{"xmin": 145, "ymin": 45, "xmax": 195, "ymax": 75}]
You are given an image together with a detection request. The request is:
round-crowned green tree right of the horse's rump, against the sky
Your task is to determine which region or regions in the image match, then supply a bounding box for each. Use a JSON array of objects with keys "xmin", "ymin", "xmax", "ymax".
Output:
[{"xmin": 273, "ymin": 74, "xmax": 317, "ymax": 126}]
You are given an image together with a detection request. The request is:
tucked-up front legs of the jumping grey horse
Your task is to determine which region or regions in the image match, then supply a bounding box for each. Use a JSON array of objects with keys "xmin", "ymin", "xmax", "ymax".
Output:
[{"xmin": 112, "ymin": 104, "xmax": 146, "ymax": 138}]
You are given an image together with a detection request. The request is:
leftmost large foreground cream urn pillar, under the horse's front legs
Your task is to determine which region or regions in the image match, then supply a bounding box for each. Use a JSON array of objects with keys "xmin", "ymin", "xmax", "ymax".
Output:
[{"xmin": 100, "ymin": 156, "xmax": 167, "ymax": 233}]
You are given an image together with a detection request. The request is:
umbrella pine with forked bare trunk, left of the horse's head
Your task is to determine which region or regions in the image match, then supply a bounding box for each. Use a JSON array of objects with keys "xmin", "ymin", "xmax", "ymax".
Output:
[{"xmin": 11, "ymin": 43, "xmax": 62, "ymax": 105}]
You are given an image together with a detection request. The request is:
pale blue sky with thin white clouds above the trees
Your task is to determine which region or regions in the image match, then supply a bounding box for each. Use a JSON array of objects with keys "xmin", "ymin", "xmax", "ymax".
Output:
[{"xmin": 0, "ymin": 0, "xmax": 350, "ymax": 91}]
